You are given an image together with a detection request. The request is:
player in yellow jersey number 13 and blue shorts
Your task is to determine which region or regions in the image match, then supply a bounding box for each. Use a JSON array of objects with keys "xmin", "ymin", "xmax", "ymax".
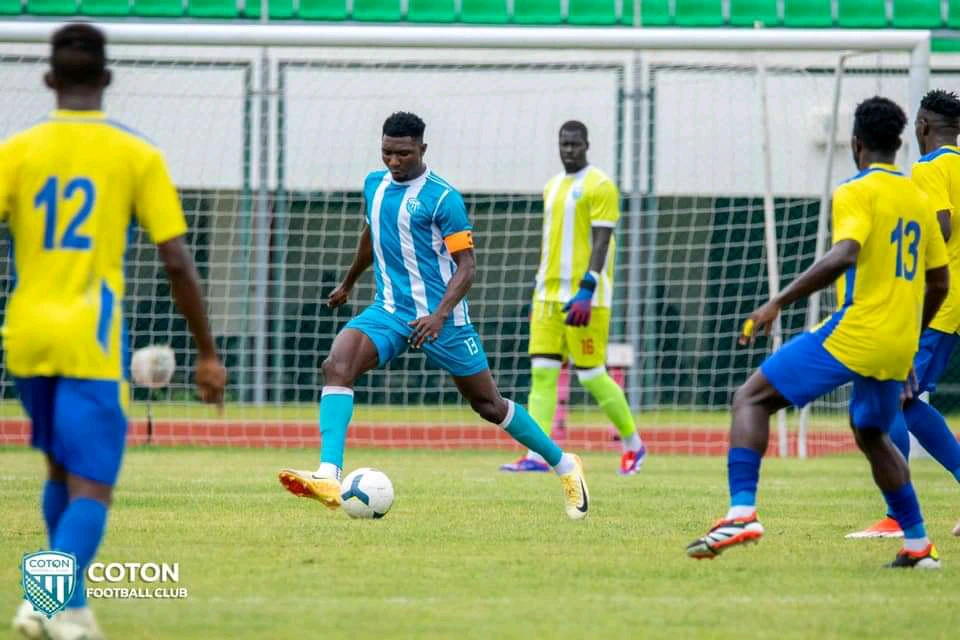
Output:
[{"xmin": 687, "ymin": 97, "xmax": 949, "ymax": 569}]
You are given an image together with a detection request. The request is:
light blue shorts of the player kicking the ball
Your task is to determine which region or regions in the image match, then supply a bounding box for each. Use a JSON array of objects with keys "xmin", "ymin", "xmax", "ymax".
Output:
[{"xmin": 344, "ymin": 307, "xmax": 490, "ymax": 378}]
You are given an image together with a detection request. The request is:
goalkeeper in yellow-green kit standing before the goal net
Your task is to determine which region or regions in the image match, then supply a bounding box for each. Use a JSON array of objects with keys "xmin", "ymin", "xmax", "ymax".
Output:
[{"xmin": 500, "ymin": 120, "xmax": 646, "ymax": 475}]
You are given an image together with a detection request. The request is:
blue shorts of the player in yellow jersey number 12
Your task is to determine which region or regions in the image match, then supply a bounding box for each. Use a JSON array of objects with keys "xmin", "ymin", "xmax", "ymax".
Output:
[{"xmin": 16, "ymin": 377, "xmax": 127, "ymax": 486}]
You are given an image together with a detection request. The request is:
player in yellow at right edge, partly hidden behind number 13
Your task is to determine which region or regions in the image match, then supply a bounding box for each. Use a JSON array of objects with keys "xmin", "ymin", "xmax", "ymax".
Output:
[{"xmin": 847, "ymin": 89, "xmax": 960, "ymax": 538}]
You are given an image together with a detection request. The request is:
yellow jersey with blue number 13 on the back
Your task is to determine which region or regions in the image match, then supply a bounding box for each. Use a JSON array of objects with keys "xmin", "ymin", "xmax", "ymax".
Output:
[{"xmin": 815, "ymin": 164, "xmax": 948, "ymax": 380}]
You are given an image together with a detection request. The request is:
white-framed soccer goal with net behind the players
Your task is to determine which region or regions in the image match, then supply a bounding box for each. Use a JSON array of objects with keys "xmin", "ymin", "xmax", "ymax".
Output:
[{"xmin": 0, "ymin": 22, "xmax": 931, "ymax": 456}]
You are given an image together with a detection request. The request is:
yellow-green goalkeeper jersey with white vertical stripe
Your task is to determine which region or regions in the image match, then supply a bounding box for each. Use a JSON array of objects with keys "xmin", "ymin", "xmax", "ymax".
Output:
[{"xmin": 533, "ymin": 165, "xmax": 620, "ymax": 307}]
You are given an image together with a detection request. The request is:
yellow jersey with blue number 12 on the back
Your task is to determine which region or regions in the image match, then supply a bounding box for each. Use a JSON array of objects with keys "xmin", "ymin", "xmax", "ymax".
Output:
[{"xmin": 0, "ymin": 111, "xmax": 187, "ymax": 380}]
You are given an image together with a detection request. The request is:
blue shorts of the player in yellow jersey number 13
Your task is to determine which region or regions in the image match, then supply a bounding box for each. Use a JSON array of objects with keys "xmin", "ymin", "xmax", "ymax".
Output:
[{"xmin": 760, "ymin": 333, "xmax": 903, "ymax": 432}]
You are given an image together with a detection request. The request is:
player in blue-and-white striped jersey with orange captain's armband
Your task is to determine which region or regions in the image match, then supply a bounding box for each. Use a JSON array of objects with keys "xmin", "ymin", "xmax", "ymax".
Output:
[{"xmin": 280, "ymin": 112, "xmax": 589, "ymax": 520}]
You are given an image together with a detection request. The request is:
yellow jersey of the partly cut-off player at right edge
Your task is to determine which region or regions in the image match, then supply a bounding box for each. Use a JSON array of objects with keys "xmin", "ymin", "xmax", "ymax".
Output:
[{"xmin": 911, "ymin": 145, "xmax": 960, "ymax": 333}]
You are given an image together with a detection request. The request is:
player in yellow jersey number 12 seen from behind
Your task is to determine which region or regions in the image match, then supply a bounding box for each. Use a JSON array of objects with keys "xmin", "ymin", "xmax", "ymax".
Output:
[{"xmin": 6, "ymin": 23, "xmax": 226, "ymax": 640}]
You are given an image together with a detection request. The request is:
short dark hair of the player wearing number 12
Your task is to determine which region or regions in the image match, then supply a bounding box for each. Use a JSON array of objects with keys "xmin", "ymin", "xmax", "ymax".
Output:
[{"xmin": 50, "ymin": 22, "xmax": 107, "ymax": 87}]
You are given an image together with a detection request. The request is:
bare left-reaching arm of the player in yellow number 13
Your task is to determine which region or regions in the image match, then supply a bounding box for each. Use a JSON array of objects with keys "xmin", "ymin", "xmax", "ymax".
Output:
[{"xmin": 740, "ymin": 240, "xmax": 860, "ymax": 345}]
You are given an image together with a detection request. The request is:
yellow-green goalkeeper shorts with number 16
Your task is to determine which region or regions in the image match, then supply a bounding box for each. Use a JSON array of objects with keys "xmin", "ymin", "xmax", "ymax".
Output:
[{"xmin": 527, "ymin": 301, "xmax": 610, "ymax": 369}]
